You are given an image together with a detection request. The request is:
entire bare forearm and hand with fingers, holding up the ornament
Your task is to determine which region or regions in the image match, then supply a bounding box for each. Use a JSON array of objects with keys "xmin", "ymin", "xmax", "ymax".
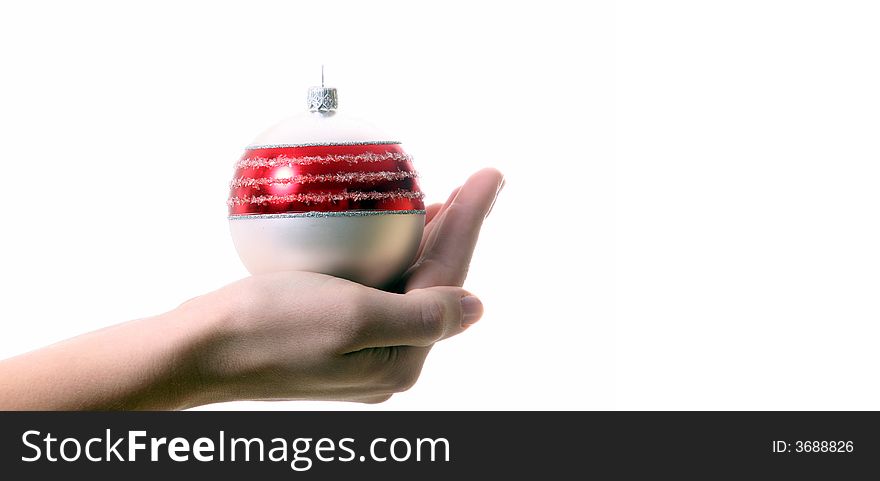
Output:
[{"xmin": 0, "ymin": 169, "xmax": 502, "ymax": 410}]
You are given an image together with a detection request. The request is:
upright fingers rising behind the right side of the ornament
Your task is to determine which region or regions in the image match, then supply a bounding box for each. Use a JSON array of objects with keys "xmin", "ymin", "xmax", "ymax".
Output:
[{"xmin": 406, "ymin": 169, "xmax": 504, "ymax": 290}]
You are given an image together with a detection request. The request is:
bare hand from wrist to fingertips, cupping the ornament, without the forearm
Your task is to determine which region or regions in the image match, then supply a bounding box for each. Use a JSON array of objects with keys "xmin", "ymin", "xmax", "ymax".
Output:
[{"xmin": 190, "ymin": 169, "xmax": 503, "ymax": 402}]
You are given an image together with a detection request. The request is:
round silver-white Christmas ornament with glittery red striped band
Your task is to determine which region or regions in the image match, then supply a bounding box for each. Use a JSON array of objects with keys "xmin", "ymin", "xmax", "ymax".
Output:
[{"xmin": 227, "ymin": 73, "xmax": 425, "ymax": 287}]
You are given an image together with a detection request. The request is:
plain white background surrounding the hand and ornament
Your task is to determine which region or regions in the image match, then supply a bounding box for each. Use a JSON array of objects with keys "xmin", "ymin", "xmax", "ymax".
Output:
[{"xmin": 0, "ymin": 1, "xmax": 880, "ymax": 409}]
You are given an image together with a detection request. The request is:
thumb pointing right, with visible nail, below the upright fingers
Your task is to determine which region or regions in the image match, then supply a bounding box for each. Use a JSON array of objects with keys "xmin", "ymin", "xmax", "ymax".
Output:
[{"xmin": 350, "ymin": 287, "xmax": 483, "ymax": 348}]
